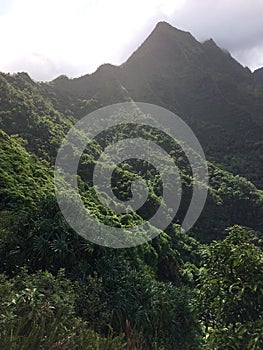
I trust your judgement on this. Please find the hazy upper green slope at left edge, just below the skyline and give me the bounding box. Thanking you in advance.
[0,73,75,160]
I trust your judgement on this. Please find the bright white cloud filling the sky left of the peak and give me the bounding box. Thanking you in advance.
[0,0,165,79]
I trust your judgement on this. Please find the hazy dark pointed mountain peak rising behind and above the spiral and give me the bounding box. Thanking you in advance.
[42,22,263,188]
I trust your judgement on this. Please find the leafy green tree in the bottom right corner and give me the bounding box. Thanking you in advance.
[198,226,263,350]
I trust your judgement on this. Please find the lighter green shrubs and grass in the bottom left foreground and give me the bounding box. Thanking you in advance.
[0,269,126,350]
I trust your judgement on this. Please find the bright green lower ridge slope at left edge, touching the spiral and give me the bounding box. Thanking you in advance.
[0,130,53,212]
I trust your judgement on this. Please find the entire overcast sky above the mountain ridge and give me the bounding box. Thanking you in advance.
[0,0,263,80]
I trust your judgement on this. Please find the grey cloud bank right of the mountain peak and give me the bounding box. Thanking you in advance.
[170,0,263,69]
